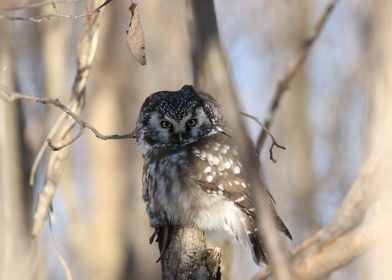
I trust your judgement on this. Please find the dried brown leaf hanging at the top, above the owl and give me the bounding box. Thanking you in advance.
[128,3,147,65]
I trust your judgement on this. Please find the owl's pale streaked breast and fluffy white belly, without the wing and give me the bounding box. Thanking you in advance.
[143,143,250,245]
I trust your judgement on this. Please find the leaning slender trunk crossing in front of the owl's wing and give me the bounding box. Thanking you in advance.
[190,0,291,280]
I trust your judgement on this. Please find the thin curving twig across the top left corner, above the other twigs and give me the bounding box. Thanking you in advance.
[0,0,113,23]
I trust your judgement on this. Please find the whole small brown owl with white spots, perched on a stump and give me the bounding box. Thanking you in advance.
[134,86,291,264]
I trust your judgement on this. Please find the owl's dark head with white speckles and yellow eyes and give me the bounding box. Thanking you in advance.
[134,85,224,154]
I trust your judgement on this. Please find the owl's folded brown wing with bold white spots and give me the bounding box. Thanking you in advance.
[190,133,292,239]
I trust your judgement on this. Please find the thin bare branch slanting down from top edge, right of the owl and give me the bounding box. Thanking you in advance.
[256,0,339,153]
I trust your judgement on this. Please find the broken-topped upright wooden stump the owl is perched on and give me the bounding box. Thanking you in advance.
[158,226,221,280]
